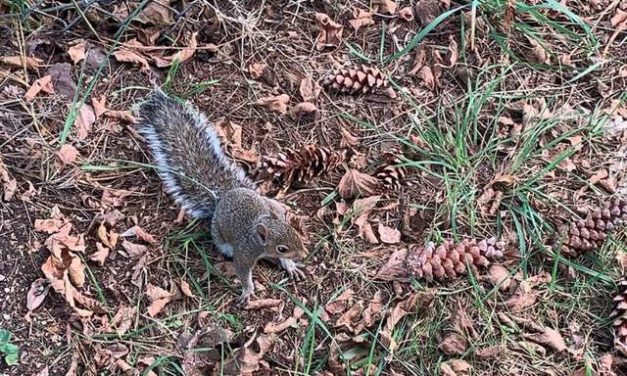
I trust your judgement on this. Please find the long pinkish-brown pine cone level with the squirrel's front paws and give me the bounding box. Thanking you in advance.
[405,238,505,281]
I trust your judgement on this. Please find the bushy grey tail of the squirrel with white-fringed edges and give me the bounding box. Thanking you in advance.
[138,88,254,218]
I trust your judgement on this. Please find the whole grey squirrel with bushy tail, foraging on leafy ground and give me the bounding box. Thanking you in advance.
[137,87,307,305]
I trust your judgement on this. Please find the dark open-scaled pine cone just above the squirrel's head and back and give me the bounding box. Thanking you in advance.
[252,145,345,189]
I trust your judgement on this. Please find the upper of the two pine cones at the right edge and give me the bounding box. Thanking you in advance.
[560,200,627,257]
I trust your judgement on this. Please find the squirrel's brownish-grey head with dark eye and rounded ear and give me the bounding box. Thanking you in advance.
[254,214,307,259]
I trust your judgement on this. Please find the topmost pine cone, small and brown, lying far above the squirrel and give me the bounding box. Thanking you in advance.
[323,65,388,94]
